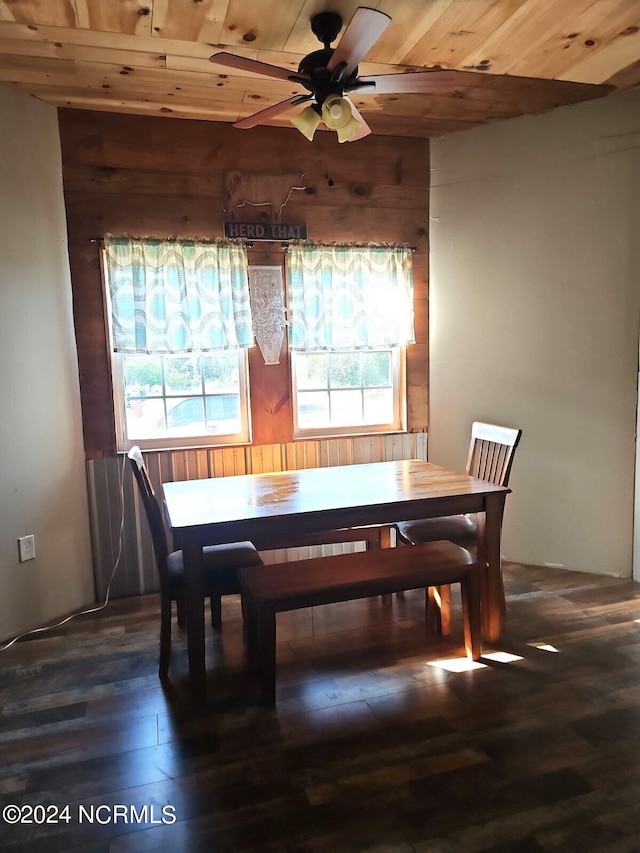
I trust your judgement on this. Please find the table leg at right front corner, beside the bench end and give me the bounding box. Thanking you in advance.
[478,492,506,642]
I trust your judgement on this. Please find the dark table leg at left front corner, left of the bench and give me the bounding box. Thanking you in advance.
[182,536,206,705]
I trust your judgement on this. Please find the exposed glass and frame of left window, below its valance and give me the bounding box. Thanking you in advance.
[114,350,250,448]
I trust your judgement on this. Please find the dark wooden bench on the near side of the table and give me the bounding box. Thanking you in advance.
[239,542,481,705]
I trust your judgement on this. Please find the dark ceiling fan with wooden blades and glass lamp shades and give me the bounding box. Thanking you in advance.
[209,6,610,142]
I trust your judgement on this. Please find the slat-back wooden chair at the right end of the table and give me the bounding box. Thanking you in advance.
[395,421,522,635]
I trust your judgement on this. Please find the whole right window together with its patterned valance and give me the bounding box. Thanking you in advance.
[287,244,413,438]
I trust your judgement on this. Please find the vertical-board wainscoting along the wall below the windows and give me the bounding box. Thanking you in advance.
[87,433,427,600]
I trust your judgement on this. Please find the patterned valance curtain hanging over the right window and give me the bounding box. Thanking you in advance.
[287,243,414,352]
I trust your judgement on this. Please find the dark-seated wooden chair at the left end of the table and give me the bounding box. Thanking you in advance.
[128,447,262,679]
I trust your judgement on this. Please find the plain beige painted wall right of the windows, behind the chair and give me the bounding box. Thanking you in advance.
[429,92,640,577]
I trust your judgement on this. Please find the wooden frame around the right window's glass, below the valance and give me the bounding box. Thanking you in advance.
[289,345,407,441]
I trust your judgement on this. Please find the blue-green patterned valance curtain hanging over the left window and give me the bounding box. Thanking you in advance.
[104,236,253,353]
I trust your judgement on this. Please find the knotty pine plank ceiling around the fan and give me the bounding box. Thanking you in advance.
[0,0,640,137]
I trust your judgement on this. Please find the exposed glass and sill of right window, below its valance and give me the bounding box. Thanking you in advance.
[291,347,405,438]
